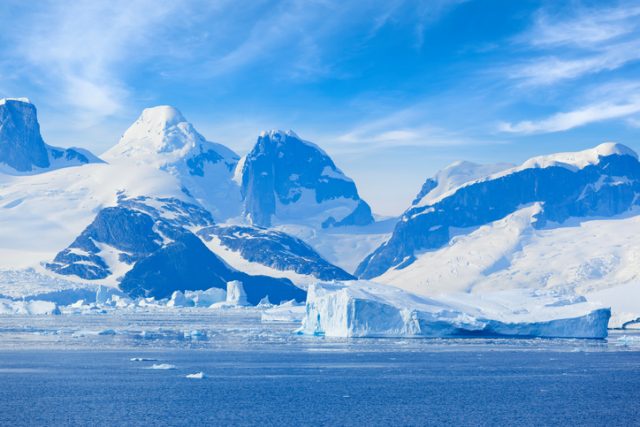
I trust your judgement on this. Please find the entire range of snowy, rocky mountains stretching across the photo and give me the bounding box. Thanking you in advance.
[0,98,640,328]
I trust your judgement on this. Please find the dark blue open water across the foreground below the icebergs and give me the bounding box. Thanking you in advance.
[0,346,640,426]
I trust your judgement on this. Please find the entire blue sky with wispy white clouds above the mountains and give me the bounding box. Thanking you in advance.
[0,0,640,215]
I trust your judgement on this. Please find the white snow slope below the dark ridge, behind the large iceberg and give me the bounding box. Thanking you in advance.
[375,204,640,327]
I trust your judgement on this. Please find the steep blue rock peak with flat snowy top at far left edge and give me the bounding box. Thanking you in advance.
[0,98,102,175]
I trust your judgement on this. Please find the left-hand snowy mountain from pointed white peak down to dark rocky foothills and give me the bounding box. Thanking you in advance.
[0,104,351,302]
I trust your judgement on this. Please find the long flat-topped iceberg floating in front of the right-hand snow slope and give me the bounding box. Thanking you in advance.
[299,281,611,338]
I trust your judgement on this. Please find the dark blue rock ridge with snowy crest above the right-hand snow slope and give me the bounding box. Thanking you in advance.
[356,144,640,278]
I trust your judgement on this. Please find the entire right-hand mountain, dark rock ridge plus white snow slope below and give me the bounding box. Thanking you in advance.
[358,143,640,328]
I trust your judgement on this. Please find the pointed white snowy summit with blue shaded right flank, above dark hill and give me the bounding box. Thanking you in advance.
[102,105,241,221]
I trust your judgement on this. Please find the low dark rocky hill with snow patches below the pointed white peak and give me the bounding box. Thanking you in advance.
[47,198,305,304]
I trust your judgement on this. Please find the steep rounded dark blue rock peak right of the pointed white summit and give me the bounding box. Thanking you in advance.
[238,130,373,228]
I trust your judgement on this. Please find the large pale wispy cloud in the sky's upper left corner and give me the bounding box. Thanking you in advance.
[3,0,180,124]
